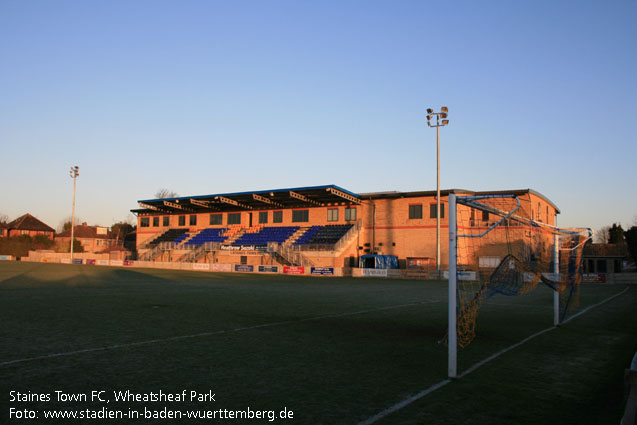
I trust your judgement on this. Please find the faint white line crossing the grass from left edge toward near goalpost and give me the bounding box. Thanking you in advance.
[0,300,440,367]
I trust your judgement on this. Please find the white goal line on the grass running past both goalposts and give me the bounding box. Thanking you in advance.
[358,287,630,425]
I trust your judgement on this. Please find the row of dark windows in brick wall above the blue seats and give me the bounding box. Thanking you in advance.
[139,208,356,227]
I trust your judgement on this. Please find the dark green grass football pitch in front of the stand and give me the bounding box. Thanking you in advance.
[0,262,637,424]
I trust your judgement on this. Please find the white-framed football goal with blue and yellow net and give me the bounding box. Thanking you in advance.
[448,193,592,377]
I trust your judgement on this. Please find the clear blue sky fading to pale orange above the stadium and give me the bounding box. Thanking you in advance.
[0,0,637,229]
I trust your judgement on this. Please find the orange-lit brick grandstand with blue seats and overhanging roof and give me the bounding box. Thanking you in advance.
[131,185,559,269]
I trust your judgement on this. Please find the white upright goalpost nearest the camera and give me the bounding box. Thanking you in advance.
[447,193,458,378]
